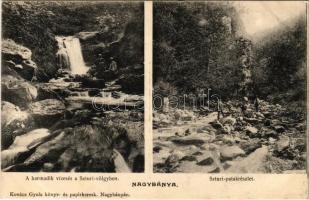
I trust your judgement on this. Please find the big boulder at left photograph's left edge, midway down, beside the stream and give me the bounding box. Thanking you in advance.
[1,75,38,107]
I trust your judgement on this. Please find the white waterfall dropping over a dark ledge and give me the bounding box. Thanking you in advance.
[56,36,89,74]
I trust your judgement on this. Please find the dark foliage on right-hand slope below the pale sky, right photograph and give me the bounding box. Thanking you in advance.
[253,16,307,102]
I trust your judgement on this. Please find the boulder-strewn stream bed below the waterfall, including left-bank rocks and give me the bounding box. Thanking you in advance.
[1,40,144,172]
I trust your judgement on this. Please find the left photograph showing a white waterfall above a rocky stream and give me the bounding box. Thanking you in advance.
[1,1,144,173]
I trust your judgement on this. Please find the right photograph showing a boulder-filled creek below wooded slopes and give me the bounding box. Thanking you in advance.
[153,1,307,174]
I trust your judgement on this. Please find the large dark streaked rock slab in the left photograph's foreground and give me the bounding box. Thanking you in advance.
[17,125,131,172]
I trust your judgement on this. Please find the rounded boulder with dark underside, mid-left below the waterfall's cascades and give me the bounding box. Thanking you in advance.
[29,99,66,127]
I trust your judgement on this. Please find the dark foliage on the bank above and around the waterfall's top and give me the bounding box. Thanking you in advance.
[2,1,143,77]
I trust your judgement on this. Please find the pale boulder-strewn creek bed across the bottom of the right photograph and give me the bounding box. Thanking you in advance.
[153,101,306,173]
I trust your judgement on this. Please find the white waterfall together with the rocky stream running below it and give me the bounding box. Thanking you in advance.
[1,36,144,172]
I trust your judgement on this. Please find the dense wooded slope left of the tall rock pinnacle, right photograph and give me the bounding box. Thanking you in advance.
[154,2,243,95]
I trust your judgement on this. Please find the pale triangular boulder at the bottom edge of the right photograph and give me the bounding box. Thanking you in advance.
[225,146,268,173]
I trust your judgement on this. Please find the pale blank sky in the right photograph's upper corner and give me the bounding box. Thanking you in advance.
[234,1,306,36]
